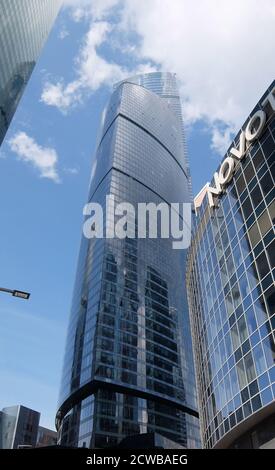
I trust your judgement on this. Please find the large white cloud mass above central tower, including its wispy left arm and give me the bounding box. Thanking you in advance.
[42,0,275,156]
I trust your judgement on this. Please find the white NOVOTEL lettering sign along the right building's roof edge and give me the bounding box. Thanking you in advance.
[206,86,275,207]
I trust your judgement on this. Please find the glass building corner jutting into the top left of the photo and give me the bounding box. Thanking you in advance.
[0,0,62,145]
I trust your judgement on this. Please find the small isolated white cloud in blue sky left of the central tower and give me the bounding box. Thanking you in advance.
[8,132,60,183]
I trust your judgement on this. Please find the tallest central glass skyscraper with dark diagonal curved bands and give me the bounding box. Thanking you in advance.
[56,73,199,448]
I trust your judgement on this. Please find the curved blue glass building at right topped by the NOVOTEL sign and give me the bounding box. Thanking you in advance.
[187,82,275,448]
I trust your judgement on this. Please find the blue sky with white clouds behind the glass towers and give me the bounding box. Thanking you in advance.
[0,0,275,427]
